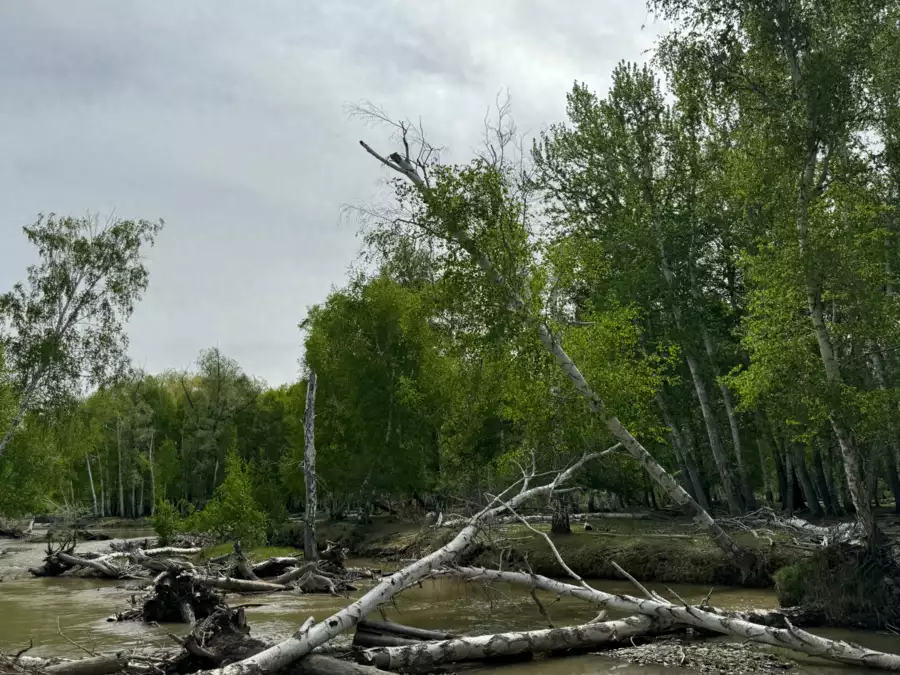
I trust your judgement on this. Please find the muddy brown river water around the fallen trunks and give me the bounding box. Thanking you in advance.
[0,530,900,675]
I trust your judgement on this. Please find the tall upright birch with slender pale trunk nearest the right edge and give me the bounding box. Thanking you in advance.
[652,0,897,542]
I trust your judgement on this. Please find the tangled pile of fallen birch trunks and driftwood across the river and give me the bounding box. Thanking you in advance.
[7,464,900,675]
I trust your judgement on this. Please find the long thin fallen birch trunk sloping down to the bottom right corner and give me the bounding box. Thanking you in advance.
[450,567,900,671]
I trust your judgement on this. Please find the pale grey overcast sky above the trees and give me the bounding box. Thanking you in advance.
[0,0,660,385]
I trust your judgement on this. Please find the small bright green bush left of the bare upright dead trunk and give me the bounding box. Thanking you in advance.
[189,452,268,547]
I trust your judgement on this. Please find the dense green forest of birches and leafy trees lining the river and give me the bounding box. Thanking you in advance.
[0,0,900,548]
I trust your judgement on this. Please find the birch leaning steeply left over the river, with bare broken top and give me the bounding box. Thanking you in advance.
[360,113,759,576]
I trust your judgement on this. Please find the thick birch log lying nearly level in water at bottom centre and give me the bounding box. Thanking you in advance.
[359,615,672,672]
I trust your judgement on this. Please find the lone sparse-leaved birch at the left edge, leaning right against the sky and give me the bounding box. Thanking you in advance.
[0,214,163,455]
